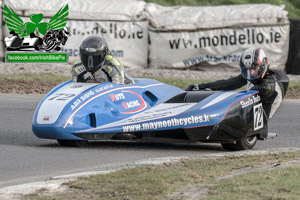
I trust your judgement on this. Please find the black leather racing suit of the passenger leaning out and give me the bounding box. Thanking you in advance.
[199,70,282,118]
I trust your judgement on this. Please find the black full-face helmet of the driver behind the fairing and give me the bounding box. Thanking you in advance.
[80,36,109,73]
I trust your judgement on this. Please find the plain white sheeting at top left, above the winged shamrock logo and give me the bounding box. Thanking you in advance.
[4,0,146,21]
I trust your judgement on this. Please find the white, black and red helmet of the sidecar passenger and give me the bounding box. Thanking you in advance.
[240,47,268,83]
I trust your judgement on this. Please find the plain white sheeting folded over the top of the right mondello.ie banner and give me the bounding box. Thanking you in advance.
[145,3,289,31]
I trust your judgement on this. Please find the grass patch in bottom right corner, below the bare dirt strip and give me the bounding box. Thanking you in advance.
[207,166,300,200]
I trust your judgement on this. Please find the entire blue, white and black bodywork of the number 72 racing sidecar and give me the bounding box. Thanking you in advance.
[32,79,267,141]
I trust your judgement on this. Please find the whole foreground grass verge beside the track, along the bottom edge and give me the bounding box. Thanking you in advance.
[24,151,300,200]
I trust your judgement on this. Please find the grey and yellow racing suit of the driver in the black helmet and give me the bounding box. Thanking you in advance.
[72,55,134,84]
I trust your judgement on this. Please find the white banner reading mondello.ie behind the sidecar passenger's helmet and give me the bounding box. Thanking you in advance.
[149,24,289,70]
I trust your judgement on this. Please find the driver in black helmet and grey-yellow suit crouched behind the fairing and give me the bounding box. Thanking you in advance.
[72,36,134,84]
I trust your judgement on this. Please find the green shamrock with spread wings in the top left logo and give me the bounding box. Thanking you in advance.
[3,4,69,37]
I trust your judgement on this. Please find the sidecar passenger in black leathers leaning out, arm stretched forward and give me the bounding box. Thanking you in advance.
[186,48,284,118]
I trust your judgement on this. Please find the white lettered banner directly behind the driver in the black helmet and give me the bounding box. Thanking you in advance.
[62,20,148,68]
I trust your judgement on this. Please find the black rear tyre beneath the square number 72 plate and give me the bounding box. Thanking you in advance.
[221,135,257,151]
